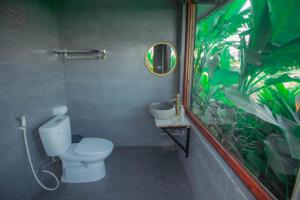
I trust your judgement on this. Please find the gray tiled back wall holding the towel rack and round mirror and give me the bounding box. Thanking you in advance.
[58,0,178,146]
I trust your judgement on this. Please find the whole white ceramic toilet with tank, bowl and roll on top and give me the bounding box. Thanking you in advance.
[39,106,113,183]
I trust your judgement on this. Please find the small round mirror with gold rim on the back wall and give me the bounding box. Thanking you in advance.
[145,42,177,76]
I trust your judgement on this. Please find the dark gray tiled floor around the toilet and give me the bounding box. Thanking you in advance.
[34,147,192,200]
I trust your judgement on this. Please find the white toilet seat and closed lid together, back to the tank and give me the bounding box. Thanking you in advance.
[60,138,113,162]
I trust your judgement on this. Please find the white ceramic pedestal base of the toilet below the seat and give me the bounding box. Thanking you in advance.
[61,160,106,183]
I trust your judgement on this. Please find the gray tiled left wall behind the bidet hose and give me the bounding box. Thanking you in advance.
[0,0,66,200]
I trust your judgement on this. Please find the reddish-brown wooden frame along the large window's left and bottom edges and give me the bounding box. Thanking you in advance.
[182,1,274,200]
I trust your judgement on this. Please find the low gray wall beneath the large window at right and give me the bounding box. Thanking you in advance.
[179,126,255,200]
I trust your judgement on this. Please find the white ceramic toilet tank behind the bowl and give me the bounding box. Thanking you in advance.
[39,115,72,156]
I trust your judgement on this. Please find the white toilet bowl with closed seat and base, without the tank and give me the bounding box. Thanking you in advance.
[60,138,113,183]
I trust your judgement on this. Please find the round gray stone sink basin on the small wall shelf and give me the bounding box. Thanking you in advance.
[149,102,176,119]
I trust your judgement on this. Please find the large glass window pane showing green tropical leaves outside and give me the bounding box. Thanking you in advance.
[190,0,300,199]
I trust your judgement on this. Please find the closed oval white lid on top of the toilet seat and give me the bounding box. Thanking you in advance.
[74,138,113,156]
